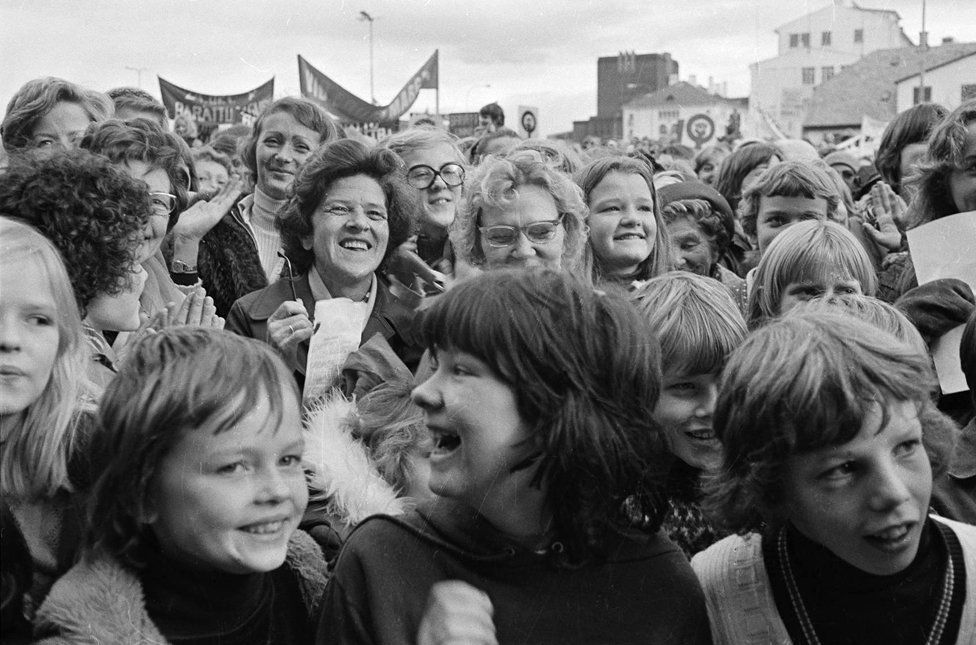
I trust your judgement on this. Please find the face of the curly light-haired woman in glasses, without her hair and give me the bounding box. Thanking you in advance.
[478,185,566,270]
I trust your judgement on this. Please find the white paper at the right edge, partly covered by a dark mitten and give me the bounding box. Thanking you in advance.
[908,211,976,394]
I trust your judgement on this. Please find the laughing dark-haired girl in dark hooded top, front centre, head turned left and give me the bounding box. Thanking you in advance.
[317,269,708,644]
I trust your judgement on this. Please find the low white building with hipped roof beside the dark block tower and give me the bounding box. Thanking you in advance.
[623,81,747,148]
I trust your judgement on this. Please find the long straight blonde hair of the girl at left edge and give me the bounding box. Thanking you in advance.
[0,217,97,500]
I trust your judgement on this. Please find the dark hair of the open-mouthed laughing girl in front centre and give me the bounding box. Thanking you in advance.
[420,269,670,562]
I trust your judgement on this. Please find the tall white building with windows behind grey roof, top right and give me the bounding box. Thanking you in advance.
[749,0,913,137]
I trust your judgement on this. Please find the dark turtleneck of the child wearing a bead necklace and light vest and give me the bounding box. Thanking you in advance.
[763,520,966,645]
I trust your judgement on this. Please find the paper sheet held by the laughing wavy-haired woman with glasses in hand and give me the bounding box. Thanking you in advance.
[302,298,369,403]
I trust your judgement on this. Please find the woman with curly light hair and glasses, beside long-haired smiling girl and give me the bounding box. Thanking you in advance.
[451,150,587,277]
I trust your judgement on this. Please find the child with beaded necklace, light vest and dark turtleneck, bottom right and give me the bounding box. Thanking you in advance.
[692,313,976,644]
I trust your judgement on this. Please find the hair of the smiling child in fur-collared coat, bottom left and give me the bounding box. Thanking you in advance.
[86,327,299,568]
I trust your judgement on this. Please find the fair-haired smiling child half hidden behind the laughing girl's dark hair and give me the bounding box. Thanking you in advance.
[633,271,746,557]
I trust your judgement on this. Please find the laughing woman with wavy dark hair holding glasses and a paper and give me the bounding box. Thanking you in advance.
[227,139,428,374]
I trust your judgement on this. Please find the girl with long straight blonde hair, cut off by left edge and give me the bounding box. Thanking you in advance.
[0,217,96,642]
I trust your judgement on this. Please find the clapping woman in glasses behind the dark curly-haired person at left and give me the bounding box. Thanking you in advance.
[81,119,225,332]
